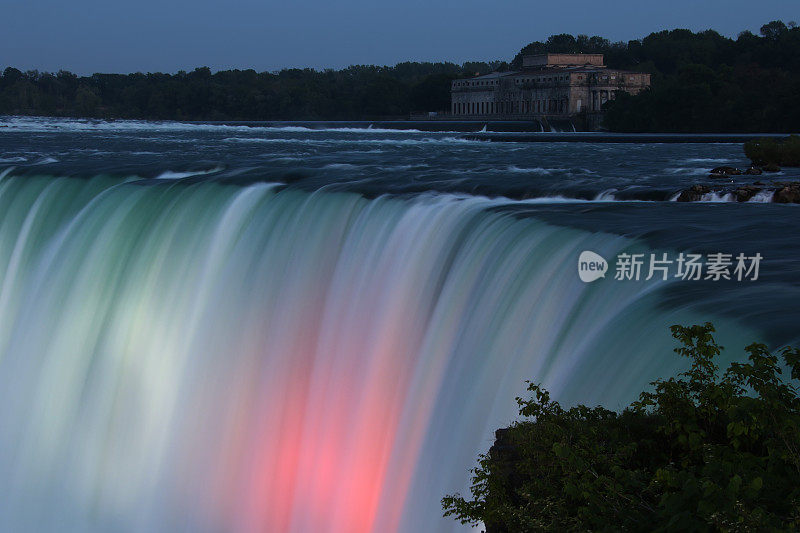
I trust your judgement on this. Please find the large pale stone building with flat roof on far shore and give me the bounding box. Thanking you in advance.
[450,54,650,120]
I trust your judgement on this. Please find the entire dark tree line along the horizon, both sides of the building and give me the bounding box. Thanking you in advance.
[0,21,800,132]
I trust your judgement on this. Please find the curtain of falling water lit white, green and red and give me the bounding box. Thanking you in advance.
[0,175,754,532]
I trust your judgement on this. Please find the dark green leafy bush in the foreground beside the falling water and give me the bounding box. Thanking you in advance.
[442,323,800,532]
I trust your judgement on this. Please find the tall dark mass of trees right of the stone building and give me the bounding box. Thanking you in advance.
[605,21,800,133]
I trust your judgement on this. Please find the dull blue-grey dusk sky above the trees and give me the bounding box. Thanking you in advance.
[0,0,800,74]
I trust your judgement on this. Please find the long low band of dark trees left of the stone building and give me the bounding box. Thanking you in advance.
[0,62,501,120]
